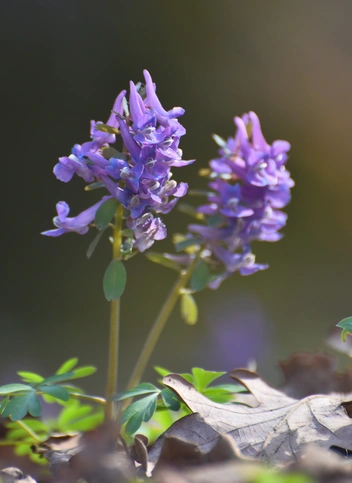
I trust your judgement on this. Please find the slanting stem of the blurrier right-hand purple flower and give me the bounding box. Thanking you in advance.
[127,249,202,389]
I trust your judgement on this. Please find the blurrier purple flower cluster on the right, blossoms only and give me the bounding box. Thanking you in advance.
[189,112,294,288]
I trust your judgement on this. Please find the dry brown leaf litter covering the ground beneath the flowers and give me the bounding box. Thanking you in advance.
[7,353,352,483]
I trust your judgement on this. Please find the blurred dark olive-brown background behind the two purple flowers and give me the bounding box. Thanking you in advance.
[0,0,352,392]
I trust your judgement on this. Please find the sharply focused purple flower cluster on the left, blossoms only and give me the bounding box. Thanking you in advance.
[43,70,194,252]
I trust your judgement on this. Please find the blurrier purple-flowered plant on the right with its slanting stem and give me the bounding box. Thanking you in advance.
[128,112,294,389]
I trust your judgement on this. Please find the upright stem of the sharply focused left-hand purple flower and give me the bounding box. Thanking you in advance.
[105,204,123,419]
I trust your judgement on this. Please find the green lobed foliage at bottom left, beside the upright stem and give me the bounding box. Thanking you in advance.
[0,358,105,462]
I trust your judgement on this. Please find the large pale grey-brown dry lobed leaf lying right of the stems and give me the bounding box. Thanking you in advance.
[163,369,352,465]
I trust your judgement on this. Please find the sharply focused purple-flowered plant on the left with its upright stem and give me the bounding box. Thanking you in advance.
[43,70,194,418]
